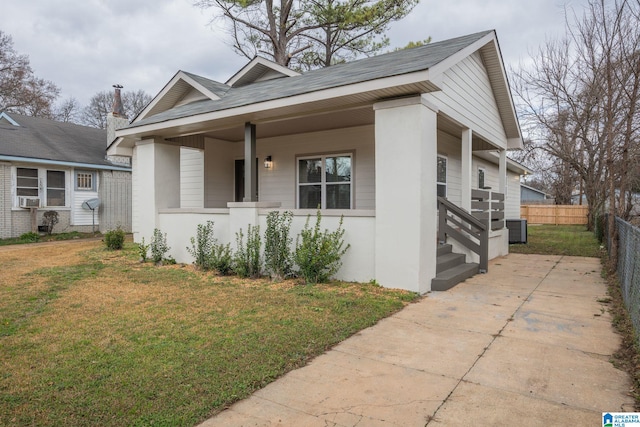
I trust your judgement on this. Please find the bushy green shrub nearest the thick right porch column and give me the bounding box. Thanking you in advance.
[295,210,351,283]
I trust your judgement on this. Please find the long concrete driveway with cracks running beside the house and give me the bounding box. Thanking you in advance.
[201,254,634,427]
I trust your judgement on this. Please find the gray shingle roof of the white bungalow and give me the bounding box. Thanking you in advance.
[128,31,492,128]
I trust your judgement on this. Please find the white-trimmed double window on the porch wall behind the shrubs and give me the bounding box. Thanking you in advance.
[298,153,353,209]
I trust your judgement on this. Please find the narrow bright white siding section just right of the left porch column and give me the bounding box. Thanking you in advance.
[180,147,204,208]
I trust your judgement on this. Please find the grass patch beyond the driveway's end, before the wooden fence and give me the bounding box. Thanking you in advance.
[509,225,601,258]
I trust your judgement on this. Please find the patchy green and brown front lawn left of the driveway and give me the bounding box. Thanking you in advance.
[0,242,417,426]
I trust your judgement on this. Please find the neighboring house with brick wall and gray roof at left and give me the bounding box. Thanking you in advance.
[0,102,131,238]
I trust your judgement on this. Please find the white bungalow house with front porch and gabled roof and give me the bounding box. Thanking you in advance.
[108,31,524,293]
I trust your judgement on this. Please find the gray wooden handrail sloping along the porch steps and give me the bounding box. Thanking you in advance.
[438,197,489,273]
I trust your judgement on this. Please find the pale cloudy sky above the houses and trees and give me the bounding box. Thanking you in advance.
[0,0,587,105]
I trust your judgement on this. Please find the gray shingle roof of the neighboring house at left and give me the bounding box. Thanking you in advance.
[0,113,129,166]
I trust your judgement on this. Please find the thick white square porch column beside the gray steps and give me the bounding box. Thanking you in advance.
[374,96,437,293]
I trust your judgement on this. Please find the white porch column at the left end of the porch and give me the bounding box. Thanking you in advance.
[132,138,180,242]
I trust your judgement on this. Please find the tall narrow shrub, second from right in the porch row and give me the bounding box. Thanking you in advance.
[264,211,293,280]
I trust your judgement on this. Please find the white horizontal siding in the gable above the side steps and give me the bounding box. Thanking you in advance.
[429,52,507,148]
